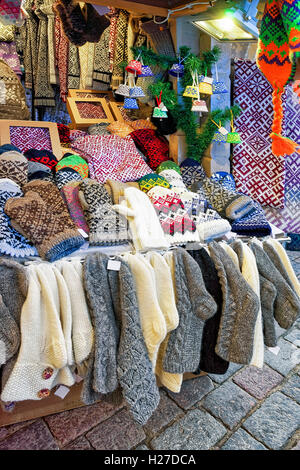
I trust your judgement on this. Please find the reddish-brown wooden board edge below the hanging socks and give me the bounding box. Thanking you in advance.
[0,372,206,428]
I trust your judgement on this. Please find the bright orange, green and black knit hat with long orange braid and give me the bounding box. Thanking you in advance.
[257,0,300,156]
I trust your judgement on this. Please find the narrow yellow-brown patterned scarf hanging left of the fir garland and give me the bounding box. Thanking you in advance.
[111,10,129,89]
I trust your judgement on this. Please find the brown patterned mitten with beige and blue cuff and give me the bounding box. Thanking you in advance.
[5,191,84,261]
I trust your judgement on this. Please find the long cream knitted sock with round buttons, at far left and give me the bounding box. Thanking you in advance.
[1,264,67,401]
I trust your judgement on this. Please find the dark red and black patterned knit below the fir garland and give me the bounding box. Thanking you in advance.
[130,129,169,171]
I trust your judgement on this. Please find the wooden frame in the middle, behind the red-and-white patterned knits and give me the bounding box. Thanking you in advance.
[67,97,115,129]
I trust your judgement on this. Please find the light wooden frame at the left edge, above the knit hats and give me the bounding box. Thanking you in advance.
[0,119,63,160]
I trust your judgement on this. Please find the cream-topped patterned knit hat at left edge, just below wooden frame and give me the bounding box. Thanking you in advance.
[0,150,28,186]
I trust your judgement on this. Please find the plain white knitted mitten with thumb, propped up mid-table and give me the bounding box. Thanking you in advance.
[114,187,170,251]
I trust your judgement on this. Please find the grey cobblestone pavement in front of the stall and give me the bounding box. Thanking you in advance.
[0,252,300,450]
